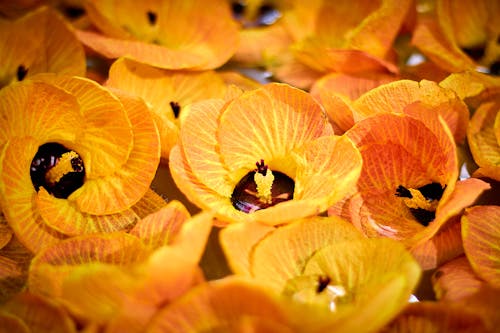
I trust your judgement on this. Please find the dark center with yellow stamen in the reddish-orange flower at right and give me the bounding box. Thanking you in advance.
[395,183,446,227]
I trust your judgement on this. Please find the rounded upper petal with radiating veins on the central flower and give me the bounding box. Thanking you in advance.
[218,84,333,179]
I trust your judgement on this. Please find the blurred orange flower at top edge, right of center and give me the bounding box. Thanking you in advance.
[271,0,412,88]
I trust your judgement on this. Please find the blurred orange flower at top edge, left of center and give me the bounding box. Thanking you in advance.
[77,0,238,70]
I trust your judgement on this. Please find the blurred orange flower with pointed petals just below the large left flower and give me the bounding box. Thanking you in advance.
[28,201,212,332]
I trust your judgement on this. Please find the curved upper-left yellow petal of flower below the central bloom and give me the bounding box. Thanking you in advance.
[250,216,362,292]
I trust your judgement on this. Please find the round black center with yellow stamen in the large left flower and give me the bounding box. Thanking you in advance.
[30,142,85,199]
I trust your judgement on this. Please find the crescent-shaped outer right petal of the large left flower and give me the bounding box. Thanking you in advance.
[75,92,160,214]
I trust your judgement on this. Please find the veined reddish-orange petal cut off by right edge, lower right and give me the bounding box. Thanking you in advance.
[462,206,500,288]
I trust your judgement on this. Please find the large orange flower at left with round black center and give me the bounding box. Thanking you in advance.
[0,75,164,252]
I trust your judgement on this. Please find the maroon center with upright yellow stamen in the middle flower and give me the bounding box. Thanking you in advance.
[231,160,295,213]
